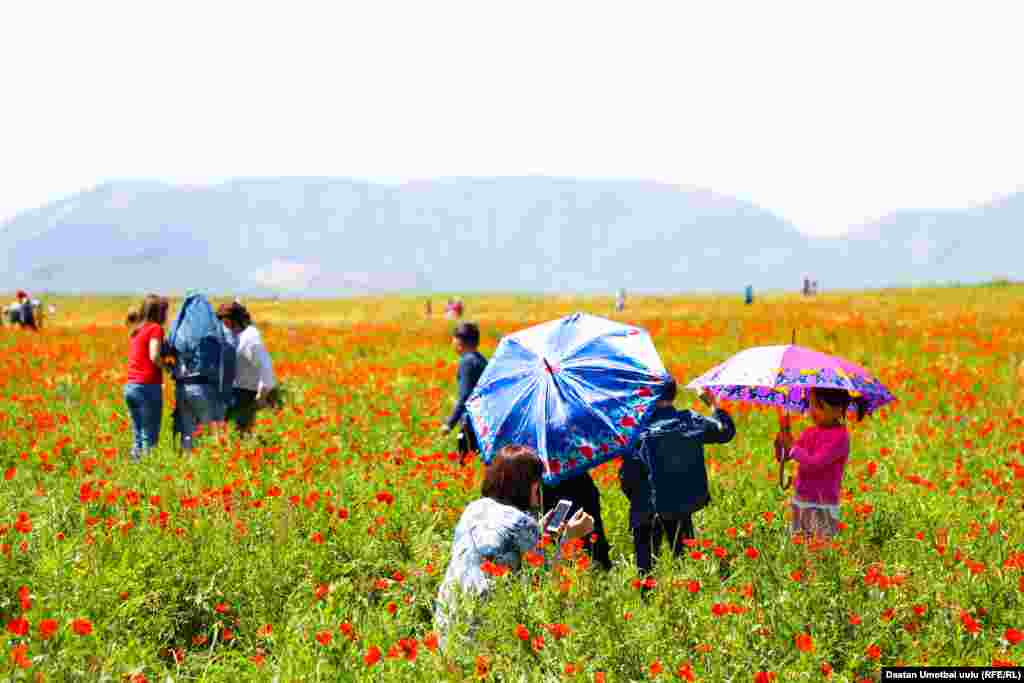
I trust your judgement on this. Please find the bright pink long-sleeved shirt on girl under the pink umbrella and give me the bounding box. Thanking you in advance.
[790,425,850,505]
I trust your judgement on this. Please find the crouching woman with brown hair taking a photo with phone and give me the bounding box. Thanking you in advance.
[434,445,594,646]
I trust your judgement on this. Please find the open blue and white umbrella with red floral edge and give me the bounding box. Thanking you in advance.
[466,313,668,483]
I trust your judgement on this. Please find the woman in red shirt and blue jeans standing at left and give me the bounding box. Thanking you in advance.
[125,294,168,462]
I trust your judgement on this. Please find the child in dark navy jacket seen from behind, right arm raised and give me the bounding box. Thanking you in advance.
[618,378,736,574]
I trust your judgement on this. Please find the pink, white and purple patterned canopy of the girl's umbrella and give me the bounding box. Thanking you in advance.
[686,345,895,413]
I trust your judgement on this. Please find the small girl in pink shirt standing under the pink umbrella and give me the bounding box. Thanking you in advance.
[775,388,864,538]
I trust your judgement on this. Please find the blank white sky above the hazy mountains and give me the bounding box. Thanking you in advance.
[0,0,1024,236]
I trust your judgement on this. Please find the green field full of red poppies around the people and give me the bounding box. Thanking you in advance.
[0,286,1024,683]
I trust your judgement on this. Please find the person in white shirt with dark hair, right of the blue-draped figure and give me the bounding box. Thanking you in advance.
[217,303,278,433]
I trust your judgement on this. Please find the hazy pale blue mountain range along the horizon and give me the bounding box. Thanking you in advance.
[0,177,1024,296]
